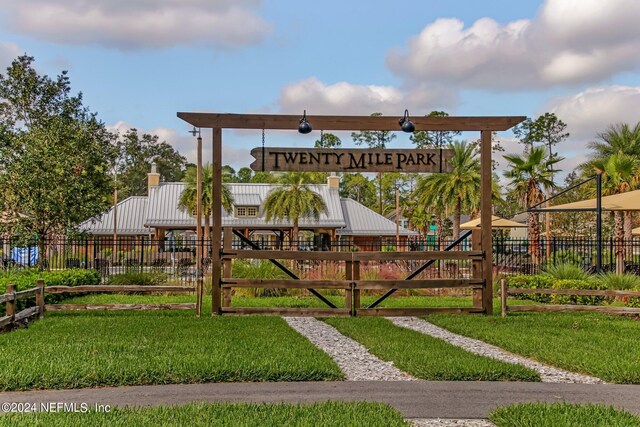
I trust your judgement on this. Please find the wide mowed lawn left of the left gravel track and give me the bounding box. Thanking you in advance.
[0,311,343,390]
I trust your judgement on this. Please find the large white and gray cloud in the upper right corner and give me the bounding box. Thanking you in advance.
[387,0,640,90]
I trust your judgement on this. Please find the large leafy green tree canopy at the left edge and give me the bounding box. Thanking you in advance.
[0,55,116,254]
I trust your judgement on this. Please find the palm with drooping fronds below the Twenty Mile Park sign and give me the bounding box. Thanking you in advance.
[264,172,327,250]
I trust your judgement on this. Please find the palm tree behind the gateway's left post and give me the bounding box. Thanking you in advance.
[178,163,233,240]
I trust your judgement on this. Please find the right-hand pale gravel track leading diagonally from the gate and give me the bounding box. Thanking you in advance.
[387,317,604,384]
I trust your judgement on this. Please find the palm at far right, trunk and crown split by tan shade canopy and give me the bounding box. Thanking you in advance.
[589,152,640,274]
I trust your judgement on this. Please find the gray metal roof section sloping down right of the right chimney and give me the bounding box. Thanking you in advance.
[336,199,418,236]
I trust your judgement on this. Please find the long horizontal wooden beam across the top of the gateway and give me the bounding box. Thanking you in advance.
[178,112,526,131]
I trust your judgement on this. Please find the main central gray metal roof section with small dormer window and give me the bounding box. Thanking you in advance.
[145,182,345,228]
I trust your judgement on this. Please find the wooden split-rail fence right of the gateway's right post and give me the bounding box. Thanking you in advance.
[500,279,640,317]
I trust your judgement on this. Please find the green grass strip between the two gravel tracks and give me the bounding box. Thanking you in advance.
[324,317,540,381]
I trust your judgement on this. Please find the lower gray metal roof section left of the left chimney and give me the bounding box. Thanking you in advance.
[78,196,152,236]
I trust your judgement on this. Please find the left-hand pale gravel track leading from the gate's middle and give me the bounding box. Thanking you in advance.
[283,317,414,381]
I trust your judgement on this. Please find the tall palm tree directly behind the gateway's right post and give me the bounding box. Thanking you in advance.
[422,142,481,239]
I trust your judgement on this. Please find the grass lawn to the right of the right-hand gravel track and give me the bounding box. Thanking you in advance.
[426,312,640,384]
